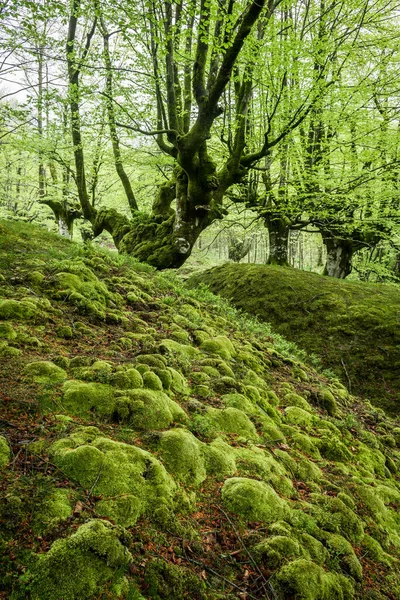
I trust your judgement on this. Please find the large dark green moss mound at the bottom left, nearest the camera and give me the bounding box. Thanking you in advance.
[31,520,132,600]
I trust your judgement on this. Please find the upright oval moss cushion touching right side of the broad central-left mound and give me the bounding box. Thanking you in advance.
[160,429,206,485]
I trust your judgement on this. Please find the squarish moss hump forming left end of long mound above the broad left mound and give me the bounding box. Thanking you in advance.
[62,379,115,417]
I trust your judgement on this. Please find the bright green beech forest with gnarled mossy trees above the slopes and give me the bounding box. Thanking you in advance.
[0,0,400,281]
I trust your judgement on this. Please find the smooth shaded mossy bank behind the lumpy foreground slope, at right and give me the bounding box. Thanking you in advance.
[190,264,400,414]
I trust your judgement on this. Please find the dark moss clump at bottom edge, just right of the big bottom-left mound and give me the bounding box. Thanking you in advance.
[144,558,207,600]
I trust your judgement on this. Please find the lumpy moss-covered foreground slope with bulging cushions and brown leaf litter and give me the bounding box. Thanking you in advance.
[0,224,400,600]
